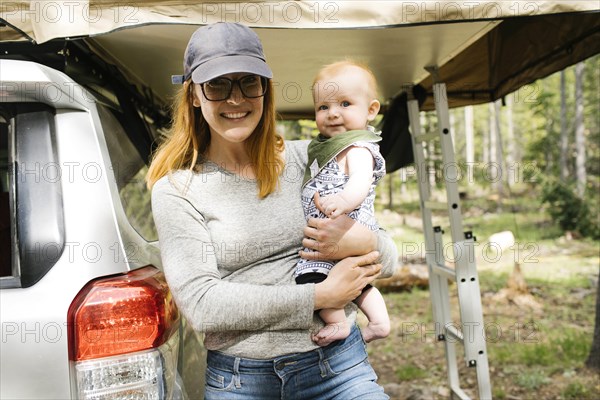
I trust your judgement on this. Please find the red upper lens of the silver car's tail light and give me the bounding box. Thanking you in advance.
[68,267,179,361]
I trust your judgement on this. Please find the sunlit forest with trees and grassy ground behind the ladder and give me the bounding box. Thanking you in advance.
[280,56,600,399]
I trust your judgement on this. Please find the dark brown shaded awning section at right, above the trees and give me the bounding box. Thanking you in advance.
[421,13,600,109]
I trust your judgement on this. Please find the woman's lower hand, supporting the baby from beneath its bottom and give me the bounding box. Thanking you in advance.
[315,251,381,310]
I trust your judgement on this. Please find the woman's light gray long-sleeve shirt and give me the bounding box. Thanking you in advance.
[152,141,397,359]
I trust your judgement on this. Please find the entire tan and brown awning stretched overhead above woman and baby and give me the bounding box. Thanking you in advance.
[0,0,600,117]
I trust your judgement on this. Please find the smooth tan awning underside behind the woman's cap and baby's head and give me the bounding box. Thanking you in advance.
[91,21,498,118]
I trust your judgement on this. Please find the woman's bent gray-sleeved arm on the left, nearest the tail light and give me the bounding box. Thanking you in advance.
[152,180,315,332]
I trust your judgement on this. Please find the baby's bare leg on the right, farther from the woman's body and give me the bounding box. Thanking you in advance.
[355,287,390,343]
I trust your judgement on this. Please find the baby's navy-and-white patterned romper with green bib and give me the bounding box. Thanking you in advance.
[295,131,385,283]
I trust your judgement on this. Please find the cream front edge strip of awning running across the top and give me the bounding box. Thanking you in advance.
[0,0,598,43]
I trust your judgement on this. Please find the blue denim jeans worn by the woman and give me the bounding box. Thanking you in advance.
[204,326,389,400]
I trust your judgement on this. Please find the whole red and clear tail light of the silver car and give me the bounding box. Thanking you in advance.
[68,267,179,400]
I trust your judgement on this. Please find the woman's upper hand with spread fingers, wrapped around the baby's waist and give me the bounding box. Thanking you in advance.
[300,193,377,260]
